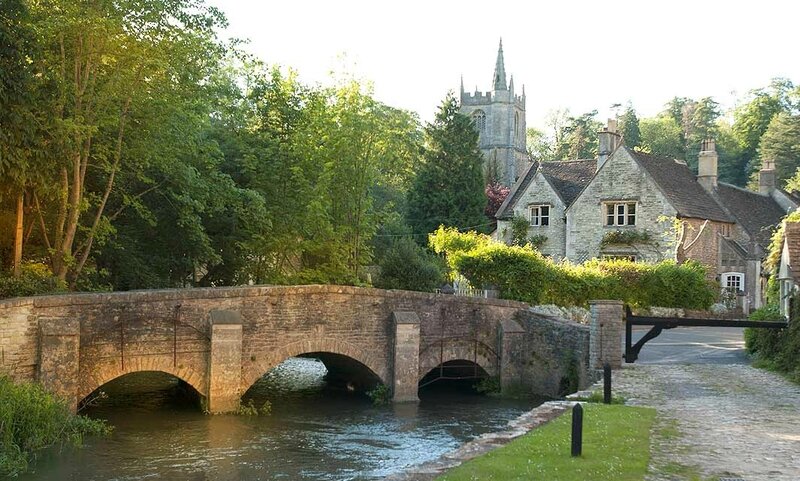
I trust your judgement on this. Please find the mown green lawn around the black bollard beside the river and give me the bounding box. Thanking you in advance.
[437,404,656,481]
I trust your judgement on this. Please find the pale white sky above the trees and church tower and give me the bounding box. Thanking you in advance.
[209,0,800,127]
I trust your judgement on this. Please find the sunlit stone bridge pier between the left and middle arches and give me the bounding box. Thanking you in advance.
[207,310,242,414]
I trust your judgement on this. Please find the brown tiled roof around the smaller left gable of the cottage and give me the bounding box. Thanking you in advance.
[497,159,597,219]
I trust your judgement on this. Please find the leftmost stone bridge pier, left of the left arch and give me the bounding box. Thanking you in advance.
[38,318,81,412]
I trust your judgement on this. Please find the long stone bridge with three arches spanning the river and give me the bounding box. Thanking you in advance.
[0,286,600,412]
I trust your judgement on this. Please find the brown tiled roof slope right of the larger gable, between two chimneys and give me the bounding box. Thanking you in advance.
[623,147,733,222]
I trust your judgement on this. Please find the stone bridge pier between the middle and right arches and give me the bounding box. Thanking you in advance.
[392,311,420,402]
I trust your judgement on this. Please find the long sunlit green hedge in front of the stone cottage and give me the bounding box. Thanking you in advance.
[430,228,718,309]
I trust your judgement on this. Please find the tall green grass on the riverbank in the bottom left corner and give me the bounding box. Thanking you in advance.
[0,376,110,478]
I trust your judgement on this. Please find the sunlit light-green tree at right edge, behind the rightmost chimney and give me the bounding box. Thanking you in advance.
[758,113,800,187]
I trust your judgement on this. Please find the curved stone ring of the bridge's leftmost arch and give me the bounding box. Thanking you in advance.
[77,357,208,402]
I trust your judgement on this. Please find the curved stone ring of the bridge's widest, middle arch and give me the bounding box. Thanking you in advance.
[240,338,390,394]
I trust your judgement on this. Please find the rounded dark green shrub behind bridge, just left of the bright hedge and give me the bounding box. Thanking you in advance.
[375,237,445,292]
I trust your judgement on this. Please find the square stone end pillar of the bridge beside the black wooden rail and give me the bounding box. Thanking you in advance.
[589,300,625,369]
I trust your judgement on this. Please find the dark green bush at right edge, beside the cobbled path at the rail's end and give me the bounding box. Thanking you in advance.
[744,299,800,383]
